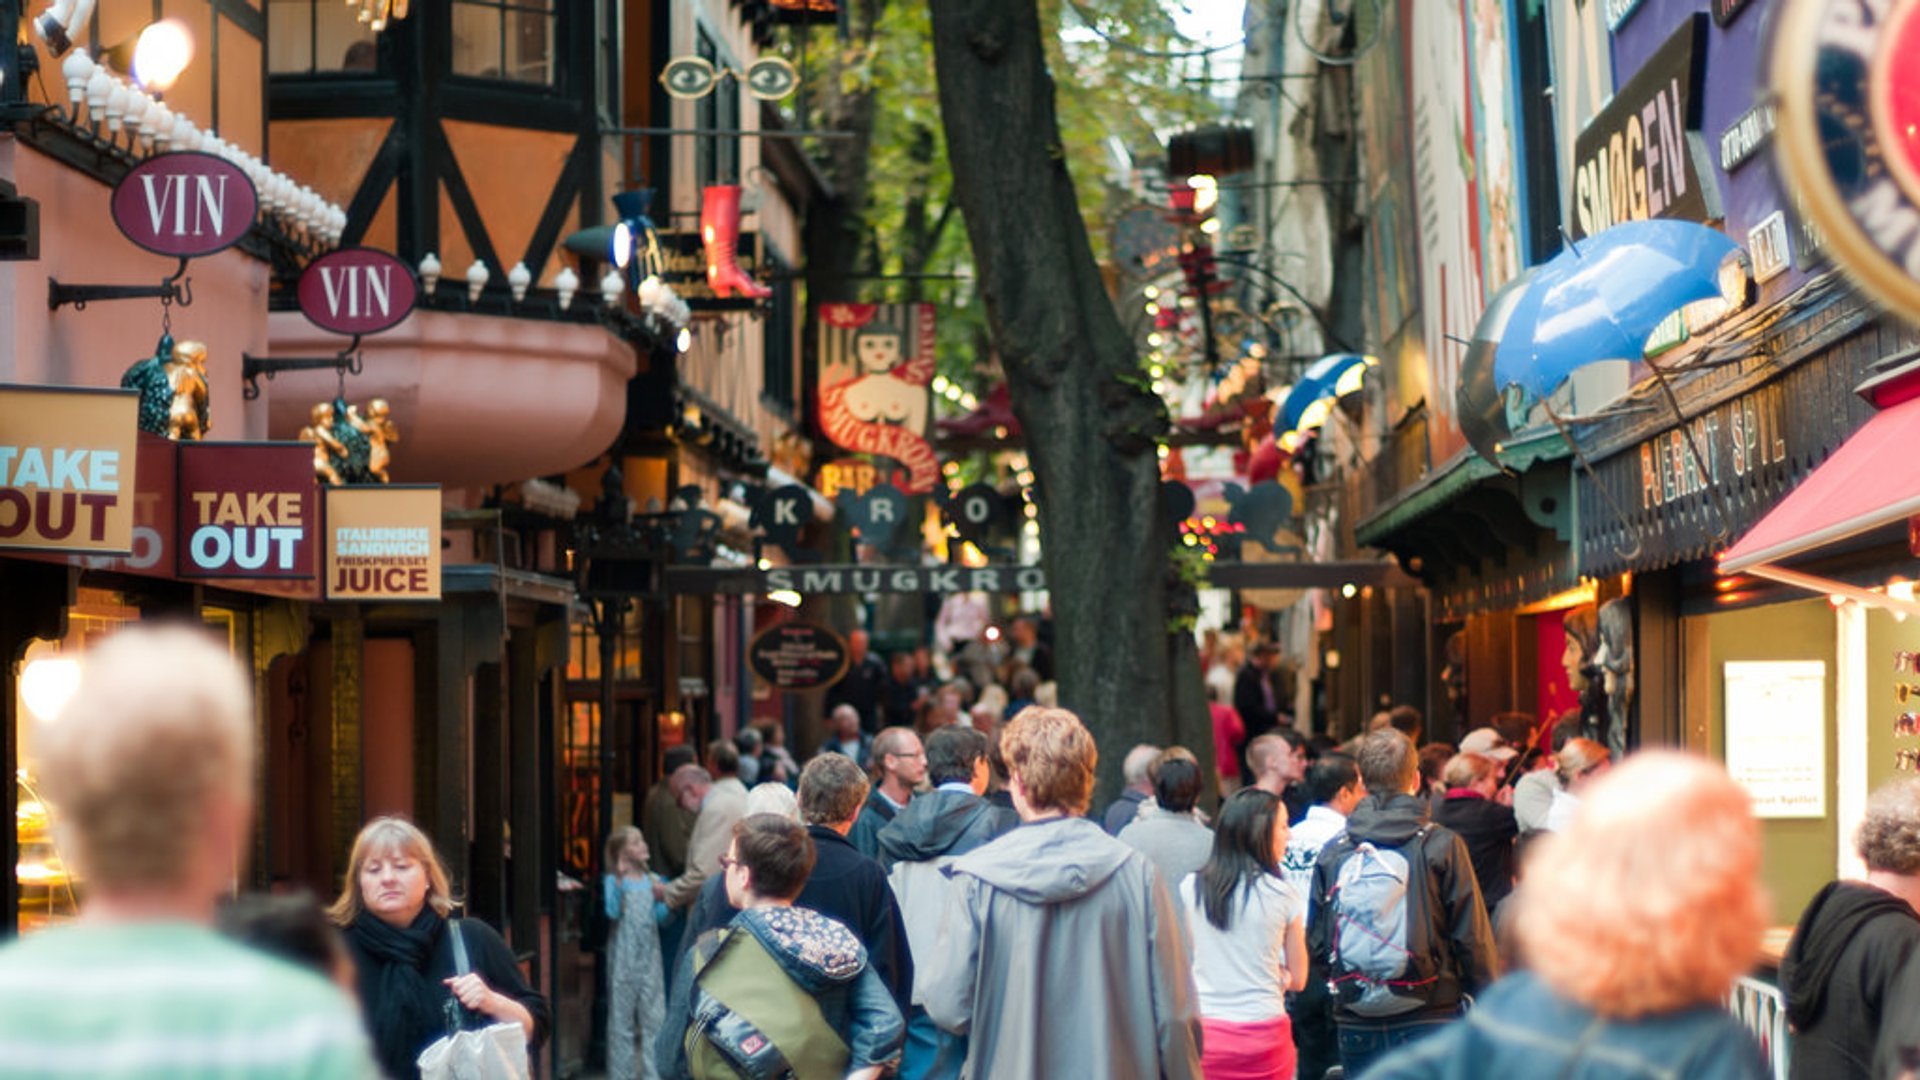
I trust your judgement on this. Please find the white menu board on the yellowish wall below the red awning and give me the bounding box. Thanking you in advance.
[1726,659,1826,817]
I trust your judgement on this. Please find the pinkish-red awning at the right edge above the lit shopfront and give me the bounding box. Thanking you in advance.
[1720,386,1920,575]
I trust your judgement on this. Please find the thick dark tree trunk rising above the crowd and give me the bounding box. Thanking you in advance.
[929,0,1213,796]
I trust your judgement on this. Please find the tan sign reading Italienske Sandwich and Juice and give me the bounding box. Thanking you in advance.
[324,484,440,600]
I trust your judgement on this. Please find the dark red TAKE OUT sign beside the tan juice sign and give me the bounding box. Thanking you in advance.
[177,442,319,580]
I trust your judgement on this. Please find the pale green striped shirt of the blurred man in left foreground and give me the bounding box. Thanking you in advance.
[0,922,378,1080]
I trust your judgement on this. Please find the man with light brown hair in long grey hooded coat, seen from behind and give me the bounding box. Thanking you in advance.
[916,705,1200,1080]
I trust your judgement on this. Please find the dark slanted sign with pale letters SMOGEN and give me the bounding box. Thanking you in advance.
[1572,15,1720,240]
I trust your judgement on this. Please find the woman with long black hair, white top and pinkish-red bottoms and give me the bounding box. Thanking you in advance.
[1181,788,1308,1080]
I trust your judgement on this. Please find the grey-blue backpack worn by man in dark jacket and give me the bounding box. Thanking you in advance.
[1329,824,1438,1017]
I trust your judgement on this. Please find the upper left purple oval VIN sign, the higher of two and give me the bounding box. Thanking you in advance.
[113,150,259,259]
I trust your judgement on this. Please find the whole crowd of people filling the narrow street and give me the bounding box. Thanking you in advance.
[18,628,1920,1080]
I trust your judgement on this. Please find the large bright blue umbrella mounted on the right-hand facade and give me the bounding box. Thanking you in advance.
[1494,221,1740,398]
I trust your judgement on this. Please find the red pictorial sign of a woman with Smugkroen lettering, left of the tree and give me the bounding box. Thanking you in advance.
[816,304,941,496]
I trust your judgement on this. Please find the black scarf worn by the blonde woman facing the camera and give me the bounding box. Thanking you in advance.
[348,905,447,1078]
